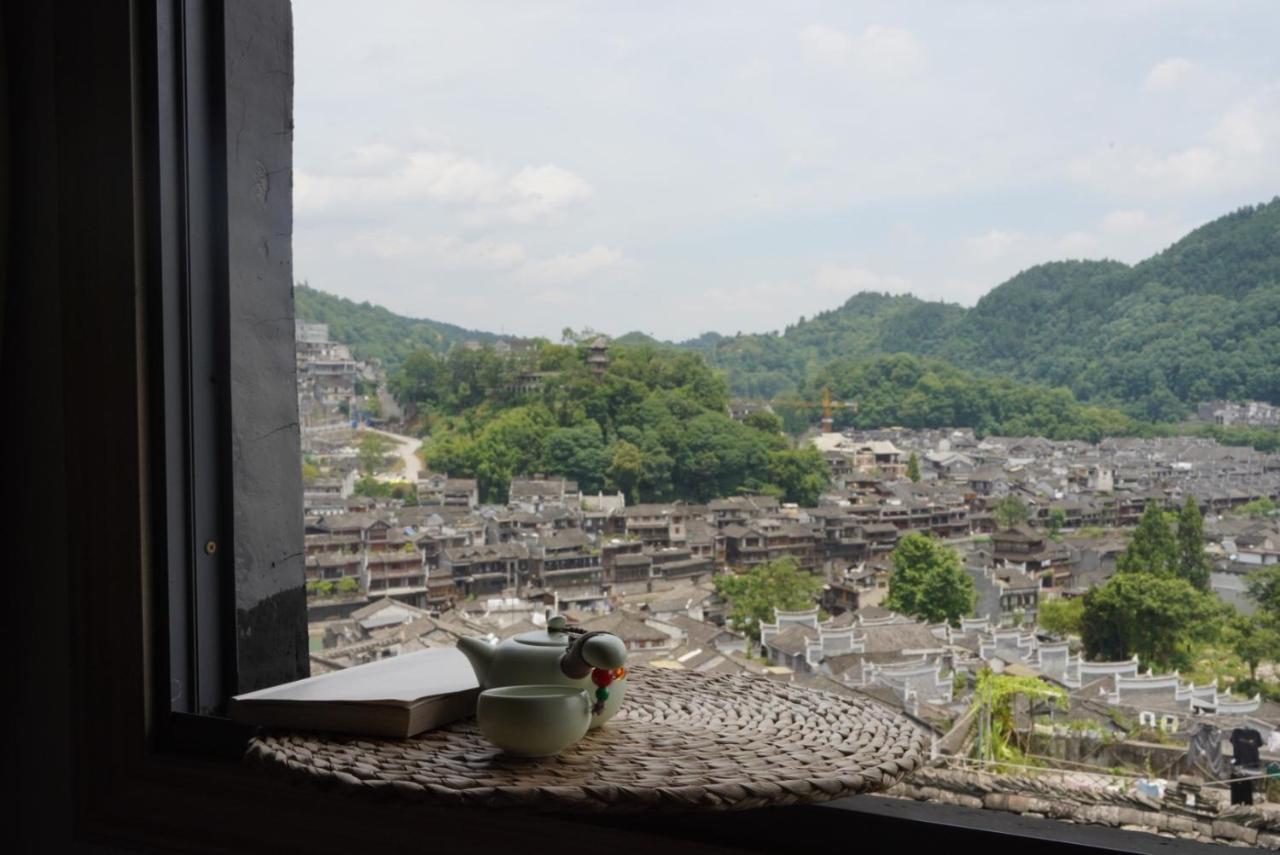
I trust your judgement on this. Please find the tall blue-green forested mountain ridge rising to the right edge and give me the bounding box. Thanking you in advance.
[684,200,1280,421]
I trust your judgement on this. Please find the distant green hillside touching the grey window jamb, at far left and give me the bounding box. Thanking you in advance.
[293,284,498,366]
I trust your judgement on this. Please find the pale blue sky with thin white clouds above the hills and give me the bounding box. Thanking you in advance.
[293,0,1280,340]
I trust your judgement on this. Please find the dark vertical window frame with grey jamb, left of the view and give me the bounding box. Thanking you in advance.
[143,0,307,732]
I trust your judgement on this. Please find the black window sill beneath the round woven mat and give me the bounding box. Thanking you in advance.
[147,715,1221,855]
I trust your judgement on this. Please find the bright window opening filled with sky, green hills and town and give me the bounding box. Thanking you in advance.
[267,3,1280,842]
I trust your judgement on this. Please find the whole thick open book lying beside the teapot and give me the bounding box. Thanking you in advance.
[229,648,480,736]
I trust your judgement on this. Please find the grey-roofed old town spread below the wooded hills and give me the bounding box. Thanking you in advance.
[298,317,1280,842]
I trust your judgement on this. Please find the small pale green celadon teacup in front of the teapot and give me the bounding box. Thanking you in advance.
[476,686,591,756]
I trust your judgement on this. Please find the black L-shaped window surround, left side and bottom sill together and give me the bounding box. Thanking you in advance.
[0,0,1233,852]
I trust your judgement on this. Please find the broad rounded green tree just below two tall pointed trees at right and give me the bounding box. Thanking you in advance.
[1080,572,1221,669]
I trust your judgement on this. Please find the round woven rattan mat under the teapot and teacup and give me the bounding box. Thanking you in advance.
[248,667,924,811]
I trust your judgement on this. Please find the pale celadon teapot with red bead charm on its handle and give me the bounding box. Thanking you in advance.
[458,614,627,727]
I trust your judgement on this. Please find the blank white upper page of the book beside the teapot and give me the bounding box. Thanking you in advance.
[234,648,479,703]
